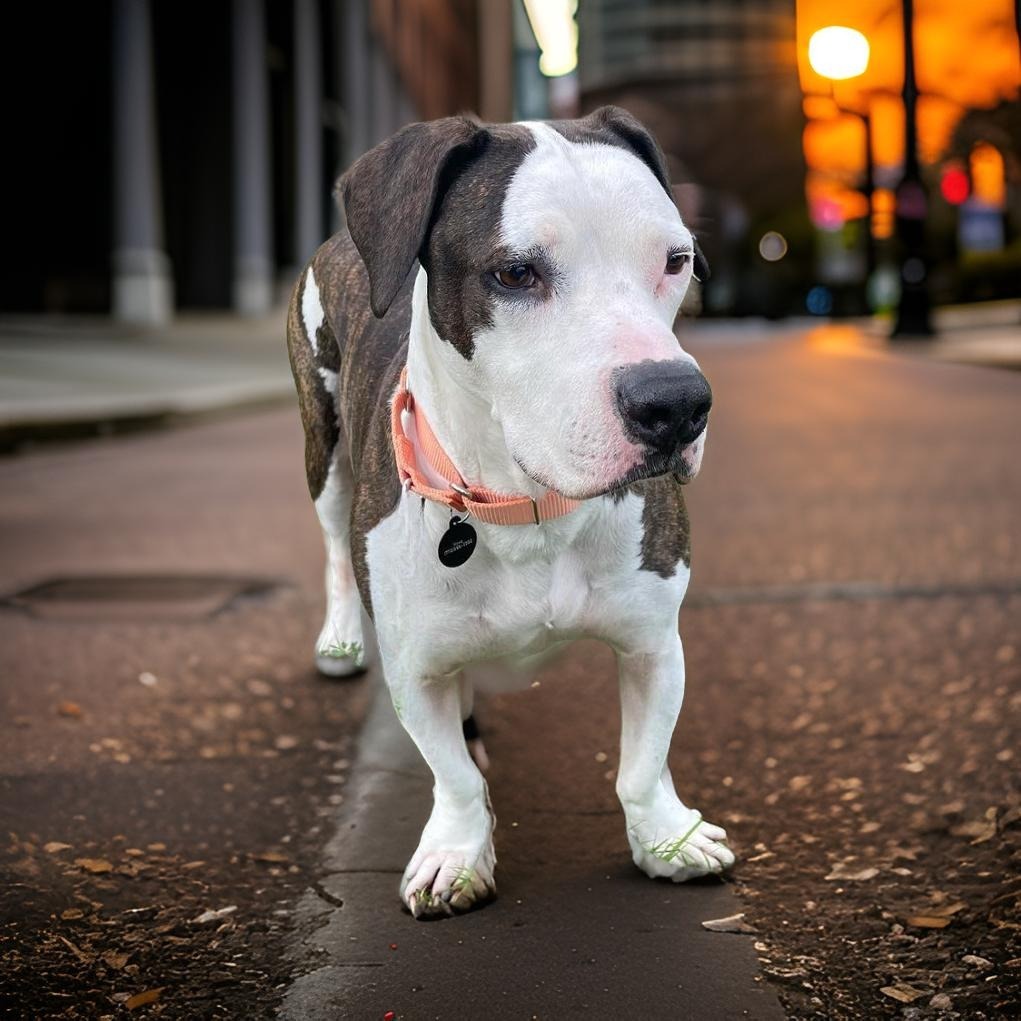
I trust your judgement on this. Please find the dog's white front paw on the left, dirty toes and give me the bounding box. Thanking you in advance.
[400,826,496,918]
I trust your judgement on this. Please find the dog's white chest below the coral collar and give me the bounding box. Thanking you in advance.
[369,496,687,672]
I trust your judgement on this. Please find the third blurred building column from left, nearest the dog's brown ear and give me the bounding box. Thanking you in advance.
[294,0,324,266]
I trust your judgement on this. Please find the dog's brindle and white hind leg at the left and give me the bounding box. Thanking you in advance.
[287,266,364,677]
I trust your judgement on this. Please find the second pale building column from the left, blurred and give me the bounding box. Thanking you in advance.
[233,0,273,315]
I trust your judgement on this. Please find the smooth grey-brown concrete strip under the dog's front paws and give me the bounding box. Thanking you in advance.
[280,669,784,1021]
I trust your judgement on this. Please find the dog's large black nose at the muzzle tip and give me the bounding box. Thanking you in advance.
[617,359,713,454]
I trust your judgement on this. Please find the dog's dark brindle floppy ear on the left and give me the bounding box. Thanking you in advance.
[336,117,488,319]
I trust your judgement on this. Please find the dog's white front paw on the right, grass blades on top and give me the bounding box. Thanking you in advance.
[628,809,734,883]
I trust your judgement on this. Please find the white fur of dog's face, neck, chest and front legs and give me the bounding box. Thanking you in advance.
[321,125,733,916]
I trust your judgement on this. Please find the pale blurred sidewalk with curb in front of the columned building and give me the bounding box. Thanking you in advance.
[0,308,294,449]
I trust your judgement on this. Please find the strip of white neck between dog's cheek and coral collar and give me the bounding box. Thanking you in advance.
[407,268,546,498]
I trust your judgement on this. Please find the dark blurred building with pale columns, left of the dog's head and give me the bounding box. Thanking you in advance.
[0,0,514,324]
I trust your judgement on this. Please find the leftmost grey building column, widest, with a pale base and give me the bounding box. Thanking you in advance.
[112,0,174,326]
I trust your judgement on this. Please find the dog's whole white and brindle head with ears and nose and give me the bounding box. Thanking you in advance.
[339,106,712,498]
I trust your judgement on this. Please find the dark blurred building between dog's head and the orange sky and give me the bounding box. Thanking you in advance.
[578,0,810,314]
